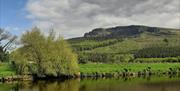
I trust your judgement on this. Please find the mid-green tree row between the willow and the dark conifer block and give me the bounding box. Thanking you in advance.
[78,53,134,63]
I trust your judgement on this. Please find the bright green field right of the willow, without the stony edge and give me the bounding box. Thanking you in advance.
[80,63,180,73]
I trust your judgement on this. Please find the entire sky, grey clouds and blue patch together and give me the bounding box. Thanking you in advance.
[0,0,180,38]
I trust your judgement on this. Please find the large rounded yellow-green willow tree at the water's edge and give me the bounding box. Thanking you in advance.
[12,28,79,77]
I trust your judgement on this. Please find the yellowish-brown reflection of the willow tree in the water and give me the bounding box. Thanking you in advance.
[14,80,79,91]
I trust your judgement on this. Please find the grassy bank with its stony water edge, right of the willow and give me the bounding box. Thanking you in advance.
[80,63,180,77]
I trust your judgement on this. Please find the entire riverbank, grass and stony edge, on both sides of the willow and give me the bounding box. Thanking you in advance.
[0,63,180,82]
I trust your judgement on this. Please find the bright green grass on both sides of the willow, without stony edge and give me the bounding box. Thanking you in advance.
[0,63,180,77]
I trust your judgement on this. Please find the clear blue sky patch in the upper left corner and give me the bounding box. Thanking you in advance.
[0,0,32,35]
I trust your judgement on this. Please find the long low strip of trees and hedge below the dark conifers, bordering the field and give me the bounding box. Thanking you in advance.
[78,53,180,64]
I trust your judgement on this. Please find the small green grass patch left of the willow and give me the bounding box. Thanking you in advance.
[0,63,16,77]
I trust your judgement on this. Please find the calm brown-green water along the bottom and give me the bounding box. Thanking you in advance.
[0,77,180,91]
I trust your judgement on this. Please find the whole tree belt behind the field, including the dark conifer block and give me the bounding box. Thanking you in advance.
[78,46,180,63]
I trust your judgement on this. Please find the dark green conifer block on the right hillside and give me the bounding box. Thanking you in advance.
[134,46,180,58]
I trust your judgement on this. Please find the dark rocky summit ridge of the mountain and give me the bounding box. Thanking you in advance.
[84,25,177,38]
